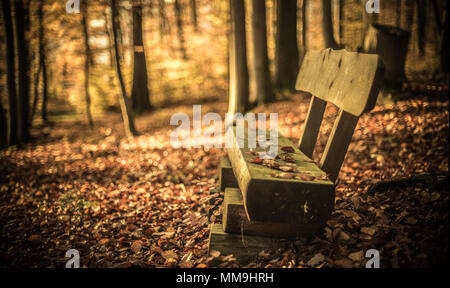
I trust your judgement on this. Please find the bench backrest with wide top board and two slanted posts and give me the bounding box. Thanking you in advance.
[295,49,384,181]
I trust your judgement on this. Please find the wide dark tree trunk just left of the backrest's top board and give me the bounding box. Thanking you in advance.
[274,0,299,89]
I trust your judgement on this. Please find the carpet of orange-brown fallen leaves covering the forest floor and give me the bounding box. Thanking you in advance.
[0,89,449,267]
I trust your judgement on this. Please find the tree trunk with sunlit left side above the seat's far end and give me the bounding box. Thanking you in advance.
[228,0,249,113]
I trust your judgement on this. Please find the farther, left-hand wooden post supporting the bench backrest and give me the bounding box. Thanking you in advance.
[299,96,327,158]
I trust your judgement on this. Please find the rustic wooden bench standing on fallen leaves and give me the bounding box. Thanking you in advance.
[210,49,384,260]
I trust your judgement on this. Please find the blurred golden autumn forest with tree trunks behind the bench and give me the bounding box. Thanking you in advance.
[0,0,448,146]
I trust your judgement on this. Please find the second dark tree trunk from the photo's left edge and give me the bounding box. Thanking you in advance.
[15,0,30,142]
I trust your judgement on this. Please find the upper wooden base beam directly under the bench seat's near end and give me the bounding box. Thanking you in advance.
[222,188,322,239]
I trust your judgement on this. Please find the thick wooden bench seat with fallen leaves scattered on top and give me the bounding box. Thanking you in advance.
[227,127,334,226]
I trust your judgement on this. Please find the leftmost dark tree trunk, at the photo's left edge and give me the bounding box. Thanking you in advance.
[2,0,19,145]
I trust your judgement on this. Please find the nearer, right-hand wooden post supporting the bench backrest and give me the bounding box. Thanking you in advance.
[320,109,359,181]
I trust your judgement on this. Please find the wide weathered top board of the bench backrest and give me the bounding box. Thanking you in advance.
[295,49,384,116]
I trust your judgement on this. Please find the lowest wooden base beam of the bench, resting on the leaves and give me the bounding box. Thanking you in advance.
[208,224,291,265]
